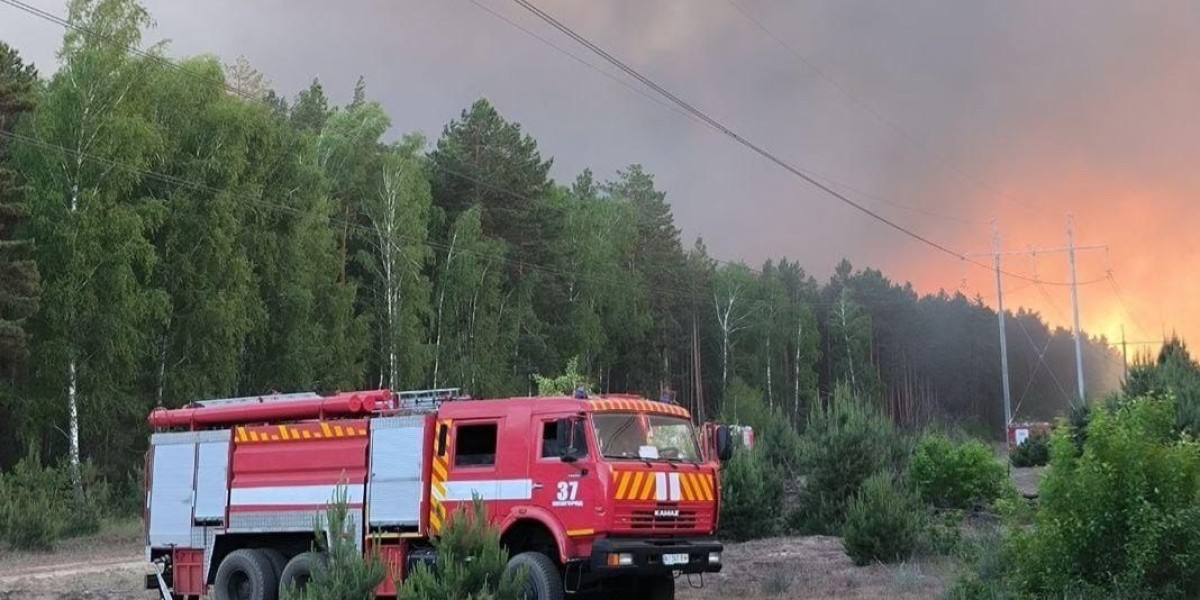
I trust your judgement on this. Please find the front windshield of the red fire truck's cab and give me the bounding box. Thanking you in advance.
[592,413,701,462]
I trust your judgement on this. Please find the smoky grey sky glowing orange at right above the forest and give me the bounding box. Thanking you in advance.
[0,0,1200,350]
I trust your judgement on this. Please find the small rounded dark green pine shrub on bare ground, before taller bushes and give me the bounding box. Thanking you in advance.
[842,473,924,566]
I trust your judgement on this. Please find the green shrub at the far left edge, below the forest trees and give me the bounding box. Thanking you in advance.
[0,450,67,552]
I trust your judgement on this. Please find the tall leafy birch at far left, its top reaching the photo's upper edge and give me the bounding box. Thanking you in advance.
[17,0,163,494]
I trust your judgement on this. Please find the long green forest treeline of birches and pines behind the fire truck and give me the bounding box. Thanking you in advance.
[0,0,1121,476]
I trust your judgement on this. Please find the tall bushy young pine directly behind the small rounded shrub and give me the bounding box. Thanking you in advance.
[791,386,910,534]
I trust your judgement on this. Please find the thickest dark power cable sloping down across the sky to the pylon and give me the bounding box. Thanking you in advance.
[512,0,1094,286]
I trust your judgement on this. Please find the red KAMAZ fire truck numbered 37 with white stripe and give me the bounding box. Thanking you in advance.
[145,390,732,600]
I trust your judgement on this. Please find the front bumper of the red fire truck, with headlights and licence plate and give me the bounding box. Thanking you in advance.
[590,538,725,576]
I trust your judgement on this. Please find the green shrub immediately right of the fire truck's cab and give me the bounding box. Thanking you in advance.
[720,448,784,541]
